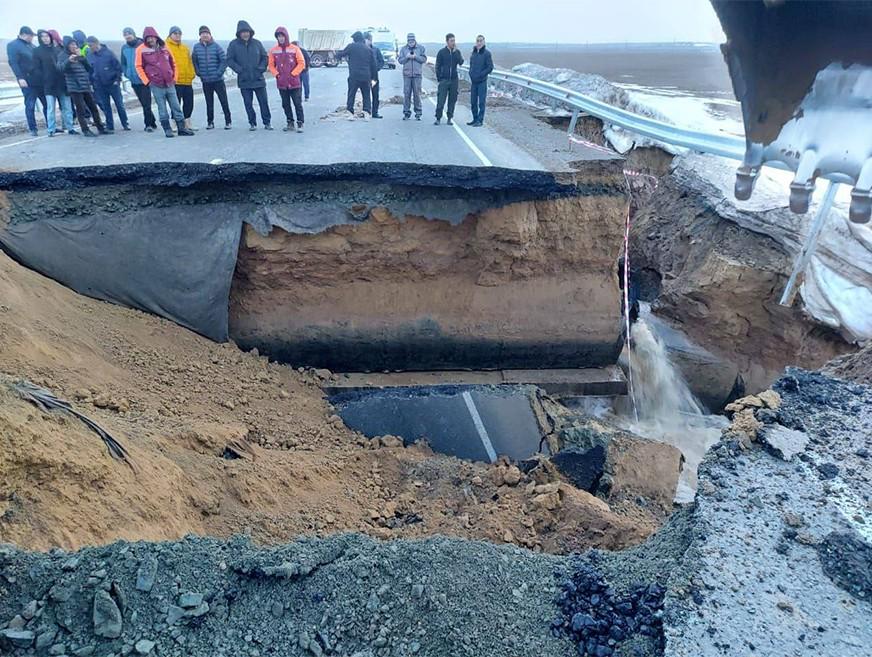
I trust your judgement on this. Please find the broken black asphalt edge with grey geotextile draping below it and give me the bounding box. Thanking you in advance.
[0,163,623,358]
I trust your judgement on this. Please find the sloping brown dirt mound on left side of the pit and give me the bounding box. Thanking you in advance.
[0,255,660,552]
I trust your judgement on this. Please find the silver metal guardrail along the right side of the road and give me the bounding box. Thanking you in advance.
[461,66,745,160]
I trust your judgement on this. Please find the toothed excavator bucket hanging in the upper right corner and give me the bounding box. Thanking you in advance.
[711,0,872,223]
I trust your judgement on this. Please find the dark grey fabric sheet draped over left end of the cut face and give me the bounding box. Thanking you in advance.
[0,207,242,342]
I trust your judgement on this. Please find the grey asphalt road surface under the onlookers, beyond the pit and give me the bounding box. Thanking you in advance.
[0,67,545,170]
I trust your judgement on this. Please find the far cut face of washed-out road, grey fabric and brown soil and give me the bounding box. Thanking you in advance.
[0,162,626,371]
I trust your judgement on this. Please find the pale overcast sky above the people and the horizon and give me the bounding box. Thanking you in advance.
[0,0,723,43]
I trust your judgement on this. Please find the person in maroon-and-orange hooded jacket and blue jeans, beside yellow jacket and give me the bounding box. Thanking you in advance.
[136,26,194,137]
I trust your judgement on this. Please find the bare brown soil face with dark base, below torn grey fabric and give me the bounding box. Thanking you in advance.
[230,194,625,371]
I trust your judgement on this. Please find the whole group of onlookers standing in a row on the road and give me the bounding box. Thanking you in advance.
[6,20,493,137]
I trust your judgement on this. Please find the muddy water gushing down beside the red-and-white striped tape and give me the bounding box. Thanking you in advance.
[619,320,727,503]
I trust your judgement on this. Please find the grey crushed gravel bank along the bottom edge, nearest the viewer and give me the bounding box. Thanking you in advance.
[0,534,574,657]
